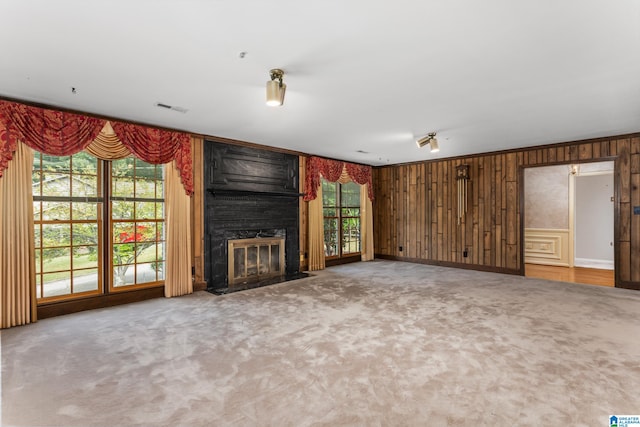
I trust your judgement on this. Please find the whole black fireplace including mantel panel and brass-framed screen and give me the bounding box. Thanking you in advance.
[202,141,301,293]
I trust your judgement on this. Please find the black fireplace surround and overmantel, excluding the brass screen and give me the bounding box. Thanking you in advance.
[204,141,300,291]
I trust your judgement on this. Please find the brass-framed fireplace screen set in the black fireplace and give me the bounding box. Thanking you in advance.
[228,237,285,287]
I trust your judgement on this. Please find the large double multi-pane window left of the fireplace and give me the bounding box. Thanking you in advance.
[32,152,164,302]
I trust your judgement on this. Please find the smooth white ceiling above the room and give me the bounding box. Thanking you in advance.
[0,0,640,165]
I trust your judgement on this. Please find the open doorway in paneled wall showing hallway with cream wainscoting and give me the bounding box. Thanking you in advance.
[523,161,615,286]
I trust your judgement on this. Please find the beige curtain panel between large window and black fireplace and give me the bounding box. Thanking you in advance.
[164,162,193,297]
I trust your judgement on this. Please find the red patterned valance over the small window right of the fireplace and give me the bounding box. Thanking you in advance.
[304,156,373,201]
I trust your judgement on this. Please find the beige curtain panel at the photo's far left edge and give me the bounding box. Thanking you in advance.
[0,142,37,328]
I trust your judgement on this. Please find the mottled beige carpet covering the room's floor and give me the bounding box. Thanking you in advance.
[1,261,640,426]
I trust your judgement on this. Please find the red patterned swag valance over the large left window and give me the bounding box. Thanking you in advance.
[0,100,193,195]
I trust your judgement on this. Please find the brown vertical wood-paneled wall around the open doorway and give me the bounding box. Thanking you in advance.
[374,134,640,289]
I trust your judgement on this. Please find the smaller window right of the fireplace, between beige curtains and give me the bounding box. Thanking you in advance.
[322,179,360,258]
